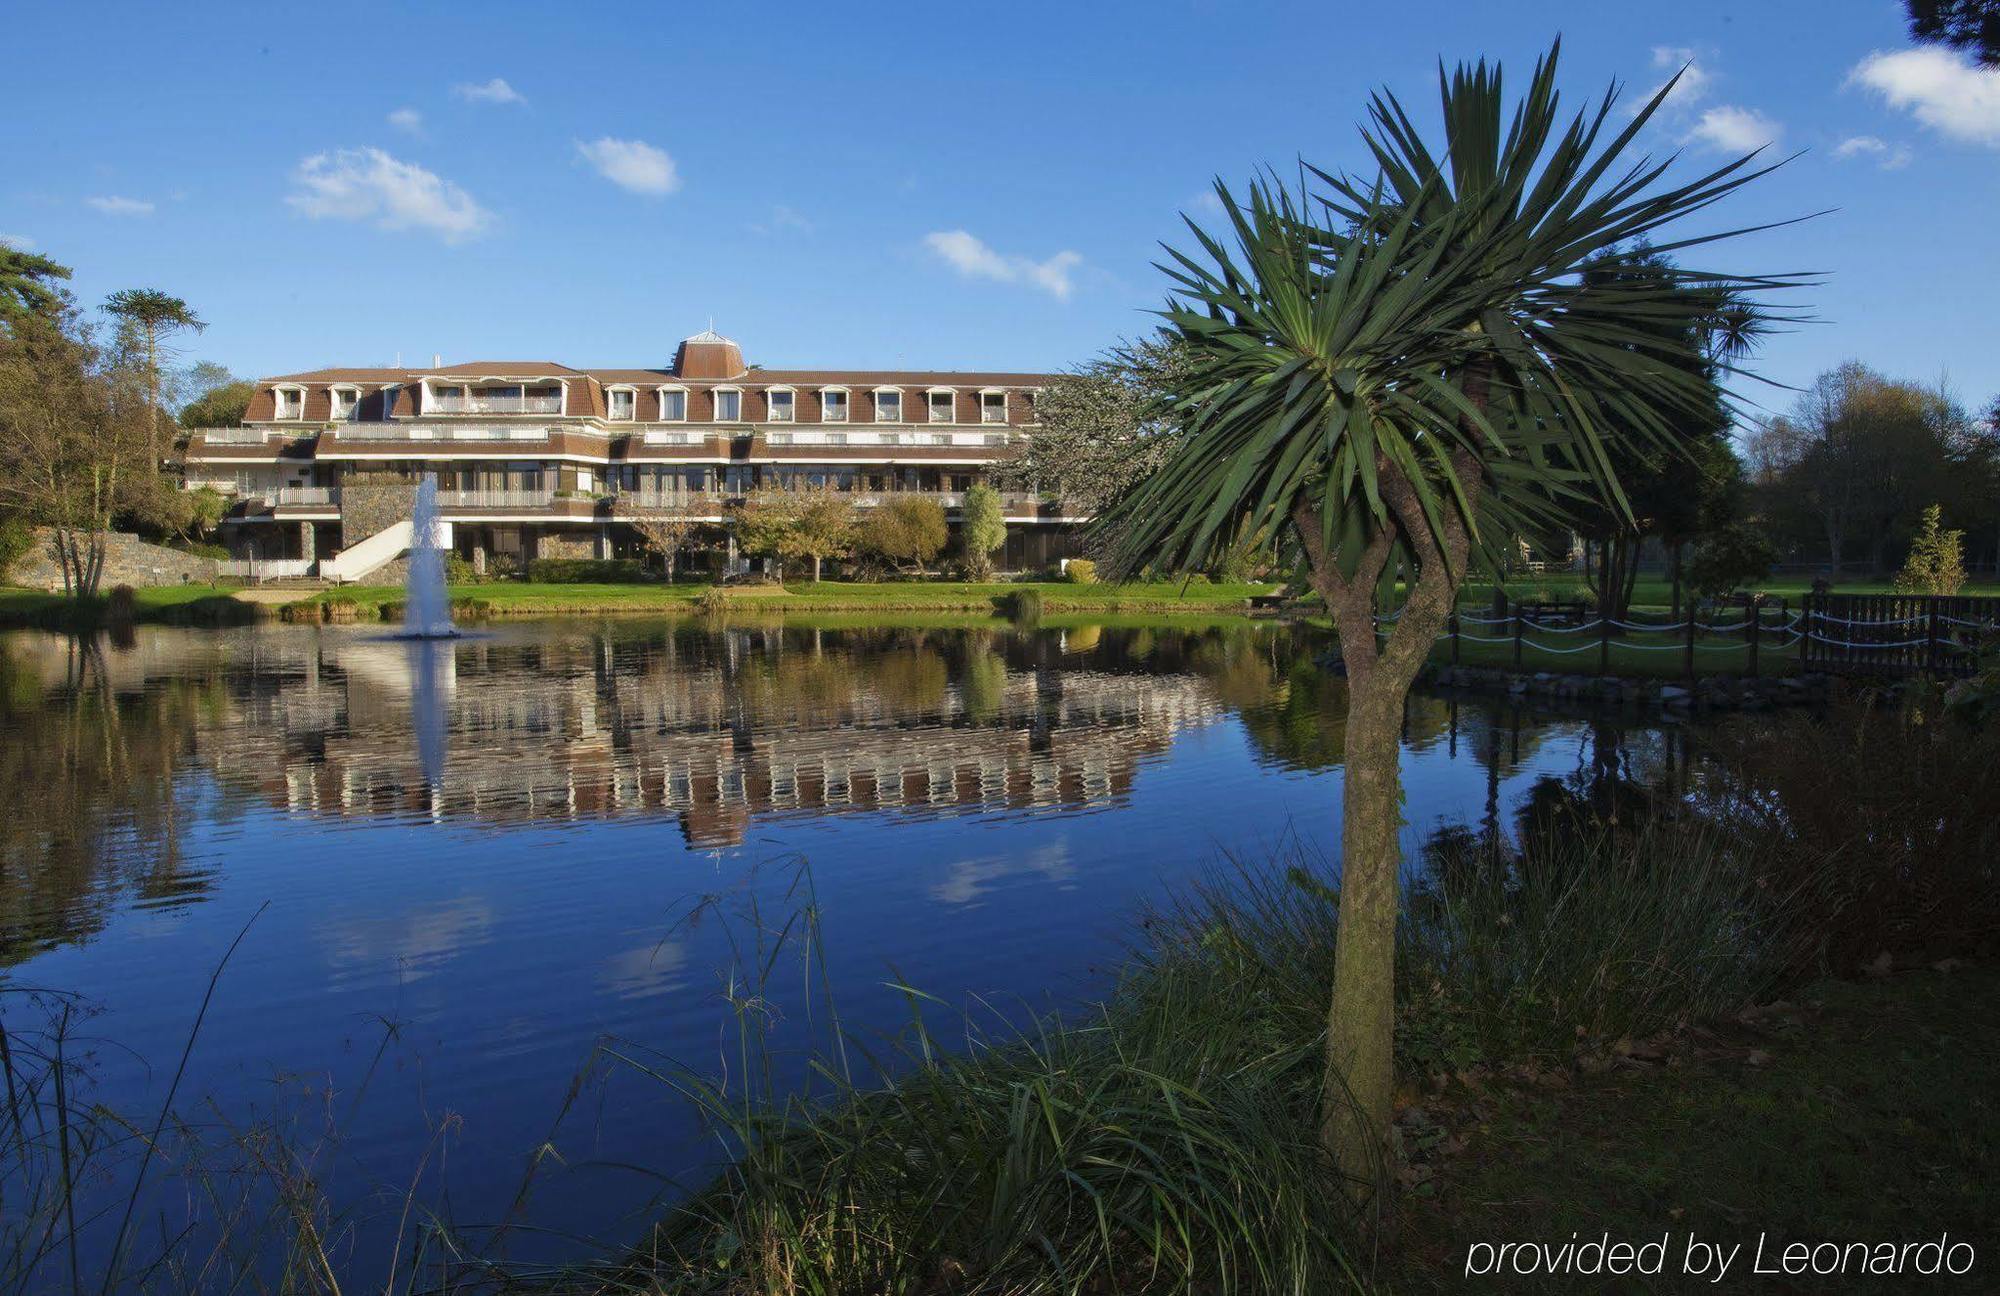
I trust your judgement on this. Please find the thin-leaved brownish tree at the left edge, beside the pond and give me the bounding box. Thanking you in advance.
[0,308,164,598]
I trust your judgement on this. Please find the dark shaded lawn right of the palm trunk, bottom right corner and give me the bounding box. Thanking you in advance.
[1382,968,2000,1292]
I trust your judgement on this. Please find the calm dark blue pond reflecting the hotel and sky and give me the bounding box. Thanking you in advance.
[0,620,1688,1252]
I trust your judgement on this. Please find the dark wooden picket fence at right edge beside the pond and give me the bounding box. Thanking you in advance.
[1800,594,2000,678]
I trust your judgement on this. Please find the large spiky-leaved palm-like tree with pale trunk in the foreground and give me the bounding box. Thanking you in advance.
[1106,50,1792,1196]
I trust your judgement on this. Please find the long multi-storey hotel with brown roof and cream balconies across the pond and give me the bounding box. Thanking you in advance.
[186,332,1084,580]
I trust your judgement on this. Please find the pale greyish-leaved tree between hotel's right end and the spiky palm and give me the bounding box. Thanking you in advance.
[994,334,1184,518]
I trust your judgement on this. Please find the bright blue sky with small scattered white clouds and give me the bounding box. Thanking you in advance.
[0,0,2000,416]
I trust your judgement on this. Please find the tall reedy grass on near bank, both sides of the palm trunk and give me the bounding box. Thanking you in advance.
[600,826,1824,1296]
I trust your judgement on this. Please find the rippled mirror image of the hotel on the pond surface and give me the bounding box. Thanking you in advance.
[168,632,1224,846]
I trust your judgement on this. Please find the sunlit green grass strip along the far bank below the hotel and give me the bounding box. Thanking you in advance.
[274,580,1272,620]
